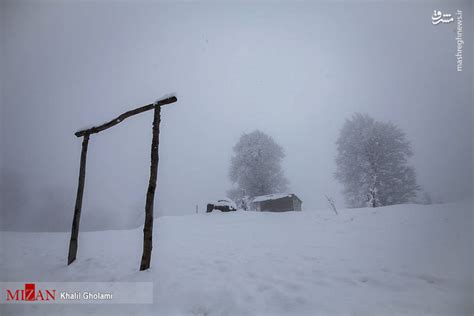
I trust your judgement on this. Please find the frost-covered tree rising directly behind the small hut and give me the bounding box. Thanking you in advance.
[228,130,288,201]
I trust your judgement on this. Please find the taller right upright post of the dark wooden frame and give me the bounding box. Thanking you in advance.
[140,106,161,271]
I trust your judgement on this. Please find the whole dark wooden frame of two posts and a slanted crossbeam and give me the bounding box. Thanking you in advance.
[67,96,178,271]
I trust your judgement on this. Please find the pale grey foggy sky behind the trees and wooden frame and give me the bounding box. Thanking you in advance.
[0,1,473,230]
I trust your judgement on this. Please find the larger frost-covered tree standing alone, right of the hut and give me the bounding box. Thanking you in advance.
[336,114,419,207]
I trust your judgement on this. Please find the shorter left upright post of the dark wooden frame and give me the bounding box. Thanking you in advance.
[67,134,89,265]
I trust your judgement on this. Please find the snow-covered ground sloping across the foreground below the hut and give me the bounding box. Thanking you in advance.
[0,201,474,315]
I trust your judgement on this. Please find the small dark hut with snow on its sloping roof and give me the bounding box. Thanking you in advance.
[250,193,303,212]
